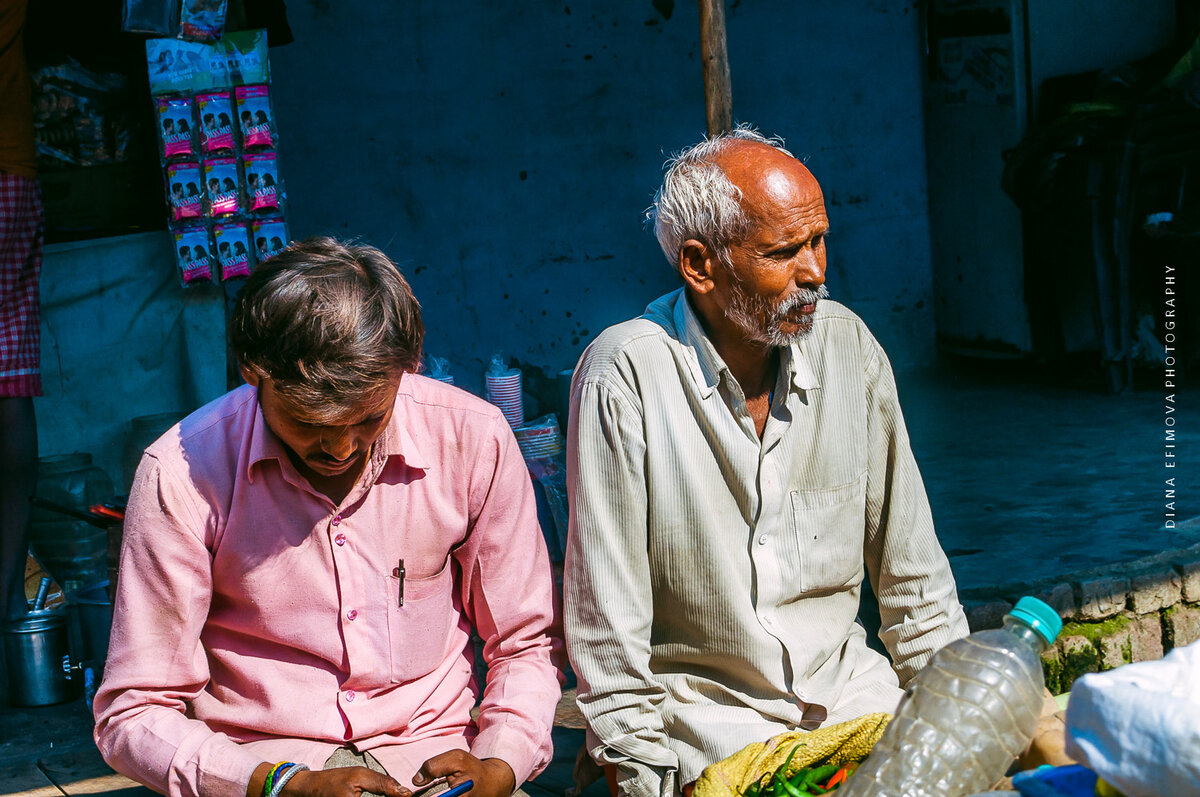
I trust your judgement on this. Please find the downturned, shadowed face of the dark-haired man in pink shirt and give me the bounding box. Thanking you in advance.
[242,370,401,479]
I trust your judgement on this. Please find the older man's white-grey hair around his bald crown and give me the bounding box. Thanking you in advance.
[646,124,794,268]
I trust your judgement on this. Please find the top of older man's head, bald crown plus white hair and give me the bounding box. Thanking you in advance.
[647,125,823,268]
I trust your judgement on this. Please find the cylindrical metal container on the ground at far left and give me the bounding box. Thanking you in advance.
[4,610,83,706]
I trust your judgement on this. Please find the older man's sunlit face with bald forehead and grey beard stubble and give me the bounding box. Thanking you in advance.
[720,145,829,346]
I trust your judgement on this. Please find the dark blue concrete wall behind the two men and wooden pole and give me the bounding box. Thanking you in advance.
[271,0,932,388]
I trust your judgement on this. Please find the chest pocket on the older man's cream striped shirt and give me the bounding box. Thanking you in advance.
[792,473,866,593]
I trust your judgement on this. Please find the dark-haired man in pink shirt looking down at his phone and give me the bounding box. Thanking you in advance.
[95,239,562,797]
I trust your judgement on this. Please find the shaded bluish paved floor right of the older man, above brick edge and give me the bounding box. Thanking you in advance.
[898,364,1200,587]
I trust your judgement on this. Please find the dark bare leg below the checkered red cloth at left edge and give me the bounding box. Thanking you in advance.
[0,397,37,617]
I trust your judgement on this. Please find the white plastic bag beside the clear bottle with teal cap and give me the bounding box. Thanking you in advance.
[1067,642,1200,797]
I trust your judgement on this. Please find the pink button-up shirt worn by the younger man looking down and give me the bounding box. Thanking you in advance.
[95,374,562,797]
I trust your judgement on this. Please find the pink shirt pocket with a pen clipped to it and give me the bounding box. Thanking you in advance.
[384,557,457,683]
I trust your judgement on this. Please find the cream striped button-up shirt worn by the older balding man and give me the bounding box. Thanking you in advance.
[565,289,967,797]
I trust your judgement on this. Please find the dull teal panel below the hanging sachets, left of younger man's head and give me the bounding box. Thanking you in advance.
[34,232,226,493]
